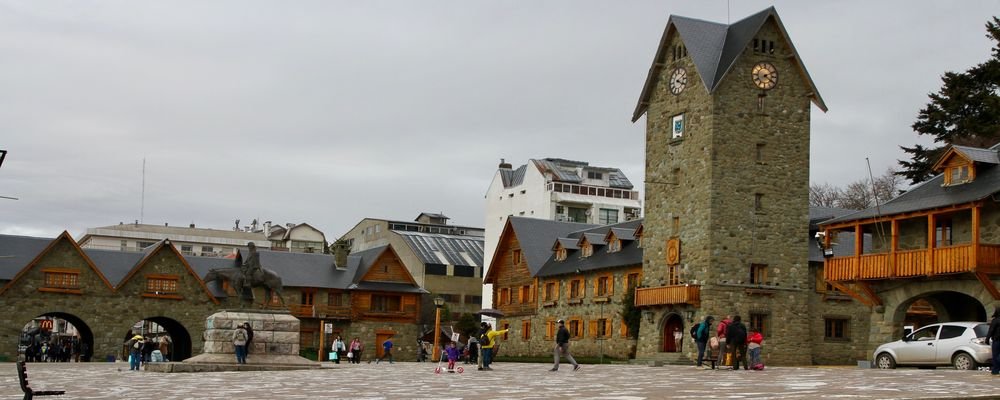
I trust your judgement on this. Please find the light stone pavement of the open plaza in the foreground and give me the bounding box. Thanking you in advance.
[0,359,1000,400]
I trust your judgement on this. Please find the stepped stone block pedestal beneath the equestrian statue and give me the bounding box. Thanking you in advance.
[147,310,321,372]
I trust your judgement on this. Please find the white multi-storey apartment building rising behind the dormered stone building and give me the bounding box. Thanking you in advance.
[485,158,642,265]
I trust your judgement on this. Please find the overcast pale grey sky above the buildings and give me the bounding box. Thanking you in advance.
[0,0,1000,241]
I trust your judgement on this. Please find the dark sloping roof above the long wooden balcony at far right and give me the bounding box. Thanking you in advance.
[822,144,1000,225]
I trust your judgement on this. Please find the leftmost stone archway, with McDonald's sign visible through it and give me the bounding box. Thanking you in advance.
[18,312,94,362]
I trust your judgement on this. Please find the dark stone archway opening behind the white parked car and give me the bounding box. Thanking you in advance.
[894,291,987,337]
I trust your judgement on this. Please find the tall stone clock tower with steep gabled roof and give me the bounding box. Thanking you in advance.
[633,7,826,363]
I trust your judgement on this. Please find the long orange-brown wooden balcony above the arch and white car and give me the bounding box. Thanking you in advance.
[824,244,1000,280]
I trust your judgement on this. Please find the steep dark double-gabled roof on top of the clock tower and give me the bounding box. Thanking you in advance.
[632,7,826,122]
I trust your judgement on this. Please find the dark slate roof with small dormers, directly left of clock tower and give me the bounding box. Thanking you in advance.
[536,219,643,277]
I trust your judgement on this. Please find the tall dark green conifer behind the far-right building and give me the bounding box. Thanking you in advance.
[899,17,1000,183]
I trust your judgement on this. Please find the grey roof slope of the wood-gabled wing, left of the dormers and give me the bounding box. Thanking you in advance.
[507,217,599,276]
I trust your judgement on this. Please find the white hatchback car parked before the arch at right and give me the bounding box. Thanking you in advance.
[873,322,992,369]
